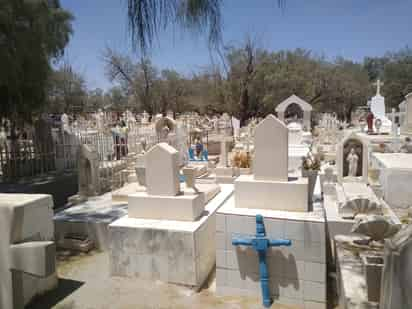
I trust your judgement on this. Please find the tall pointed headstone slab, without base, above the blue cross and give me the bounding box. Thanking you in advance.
[253,114,288,181]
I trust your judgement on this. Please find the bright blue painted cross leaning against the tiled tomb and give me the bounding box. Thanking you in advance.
[232,215,292,308]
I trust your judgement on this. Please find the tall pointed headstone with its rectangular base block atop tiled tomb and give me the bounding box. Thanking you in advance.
[235,115,308,211]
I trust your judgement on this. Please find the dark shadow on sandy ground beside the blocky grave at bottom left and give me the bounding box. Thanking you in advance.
[25,279,84,309]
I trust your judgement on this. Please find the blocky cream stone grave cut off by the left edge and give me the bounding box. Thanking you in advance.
[0,194,57,309]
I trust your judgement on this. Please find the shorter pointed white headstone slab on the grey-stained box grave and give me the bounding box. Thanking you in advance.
[145,143,180,196]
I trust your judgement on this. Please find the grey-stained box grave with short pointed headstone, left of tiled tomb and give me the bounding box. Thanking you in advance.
[109,143,232,288]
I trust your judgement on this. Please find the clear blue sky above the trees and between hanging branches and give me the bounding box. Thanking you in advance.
[61,0,412,90]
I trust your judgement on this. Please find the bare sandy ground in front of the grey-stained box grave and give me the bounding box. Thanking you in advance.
[26,250,337,309]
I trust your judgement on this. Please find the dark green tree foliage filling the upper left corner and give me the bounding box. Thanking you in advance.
[0,0,73,119]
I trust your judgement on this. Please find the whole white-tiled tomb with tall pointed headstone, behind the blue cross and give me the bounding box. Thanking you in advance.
[216,115,326,308]
